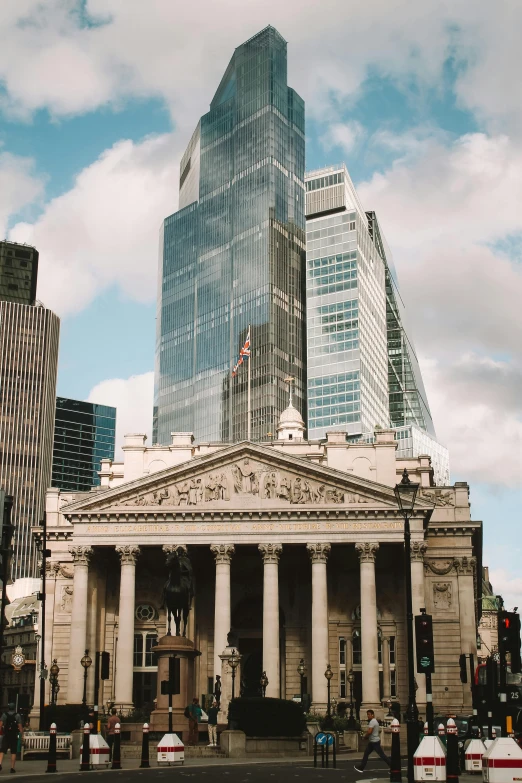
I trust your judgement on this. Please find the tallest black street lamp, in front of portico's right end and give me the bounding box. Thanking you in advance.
[394,468,419,783]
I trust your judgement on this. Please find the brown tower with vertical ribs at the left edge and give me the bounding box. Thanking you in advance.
[0,301,60,579]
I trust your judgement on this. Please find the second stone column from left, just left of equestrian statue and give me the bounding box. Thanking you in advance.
[114,544,140,712]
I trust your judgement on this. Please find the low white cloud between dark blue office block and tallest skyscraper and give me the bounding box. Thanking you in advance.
[87,372,154,460]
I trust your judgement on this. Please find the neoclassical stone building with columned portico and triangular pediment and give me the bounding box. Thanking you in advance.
[35,404,482,724]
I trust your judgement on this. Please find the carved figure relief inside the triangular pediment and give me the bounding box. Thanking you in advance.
[116,457,370,507]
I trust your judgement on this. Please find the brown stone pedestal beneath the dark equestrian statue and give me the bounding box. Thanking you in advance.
[150,636,201,742]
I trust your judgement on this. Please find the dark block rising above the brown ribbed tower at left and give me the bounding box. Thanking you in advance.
[0,240,38,305]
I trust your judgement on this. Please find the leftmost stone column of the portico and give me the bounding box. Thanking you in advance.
[67,546,93,704]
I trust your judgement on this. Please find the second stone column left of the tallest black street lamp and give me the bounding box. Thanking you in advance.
[306,543,332,710]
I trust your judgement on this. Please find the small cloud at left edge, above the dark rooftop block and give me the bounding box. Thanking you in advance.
[0,152,44,239]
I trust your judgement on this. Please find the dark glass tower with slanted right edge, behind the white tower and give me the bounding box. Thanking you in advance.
[366,212,434,434]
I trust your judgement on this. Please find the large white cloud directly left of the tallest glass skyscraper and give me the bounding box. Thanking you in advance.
[6,134,179,315]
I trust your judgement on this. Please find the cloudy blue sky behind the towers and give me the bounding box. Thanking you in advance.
[0,0,522,608]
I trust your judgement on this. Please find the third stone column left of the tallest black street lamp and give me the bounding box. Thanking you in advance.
[256,544,283,699]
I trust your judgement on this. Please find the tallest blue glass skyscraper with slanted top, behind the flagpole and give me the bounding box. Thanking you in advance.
[153,27,306,443]
